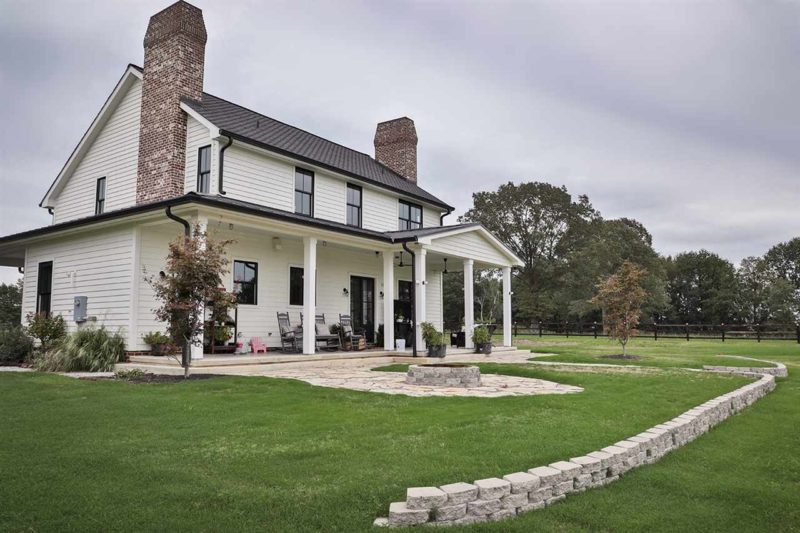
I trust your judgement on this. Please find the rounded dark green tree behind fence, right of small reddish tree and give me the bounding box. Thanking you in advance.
[667,250,737,324]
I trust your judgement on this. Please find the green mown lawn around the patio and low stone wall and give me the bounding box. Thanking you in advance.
[0,341,800,531]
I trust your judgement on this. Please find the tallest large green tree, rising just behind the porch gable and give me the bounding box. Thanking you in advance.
[459,182,600,321]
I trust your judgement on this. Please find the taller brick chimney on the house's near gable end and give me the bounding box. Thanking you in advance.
[136,0,207,204]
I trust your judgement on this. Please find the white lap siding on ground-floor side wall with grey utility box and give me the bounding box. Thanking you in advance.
[23,228,133,337]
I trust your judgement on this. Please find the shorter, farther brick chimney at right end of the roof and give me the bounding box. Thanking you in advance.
[375,117,417,183]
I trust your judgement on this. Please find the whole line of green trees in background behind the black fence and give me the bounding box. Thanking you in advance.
[444,182,800,329]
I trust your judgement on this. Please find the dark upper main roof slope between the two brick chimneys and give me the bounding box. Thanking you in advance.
[184,93,453,211]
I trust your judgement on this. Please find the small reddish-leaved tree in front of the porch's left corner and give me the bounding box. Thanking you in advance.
[145,225,236,376]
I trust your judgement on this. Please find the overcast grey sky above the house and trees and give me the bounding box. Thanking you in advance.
[0,0,800,281]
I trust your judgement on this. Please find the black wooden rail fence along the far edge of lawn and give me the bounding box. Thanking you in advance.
[514,322,800,344]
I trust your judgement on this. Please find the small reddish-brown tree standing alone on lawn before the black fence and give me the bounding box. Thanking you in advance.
[591,261,647,356]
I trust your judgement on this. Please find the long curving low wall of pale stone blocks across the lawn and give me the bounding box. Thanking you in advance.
[375,363,786,527]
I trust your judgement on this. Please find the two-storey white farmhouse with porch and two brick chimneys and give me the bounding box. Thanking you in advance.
[0,1,521,357]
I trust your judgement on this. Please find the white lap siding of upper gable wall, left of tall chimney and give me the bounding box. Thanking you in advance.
[54,81,142,223]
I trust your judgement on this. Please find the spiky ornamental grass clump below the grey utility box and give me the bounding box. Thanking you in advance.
[34,327,125,372]
